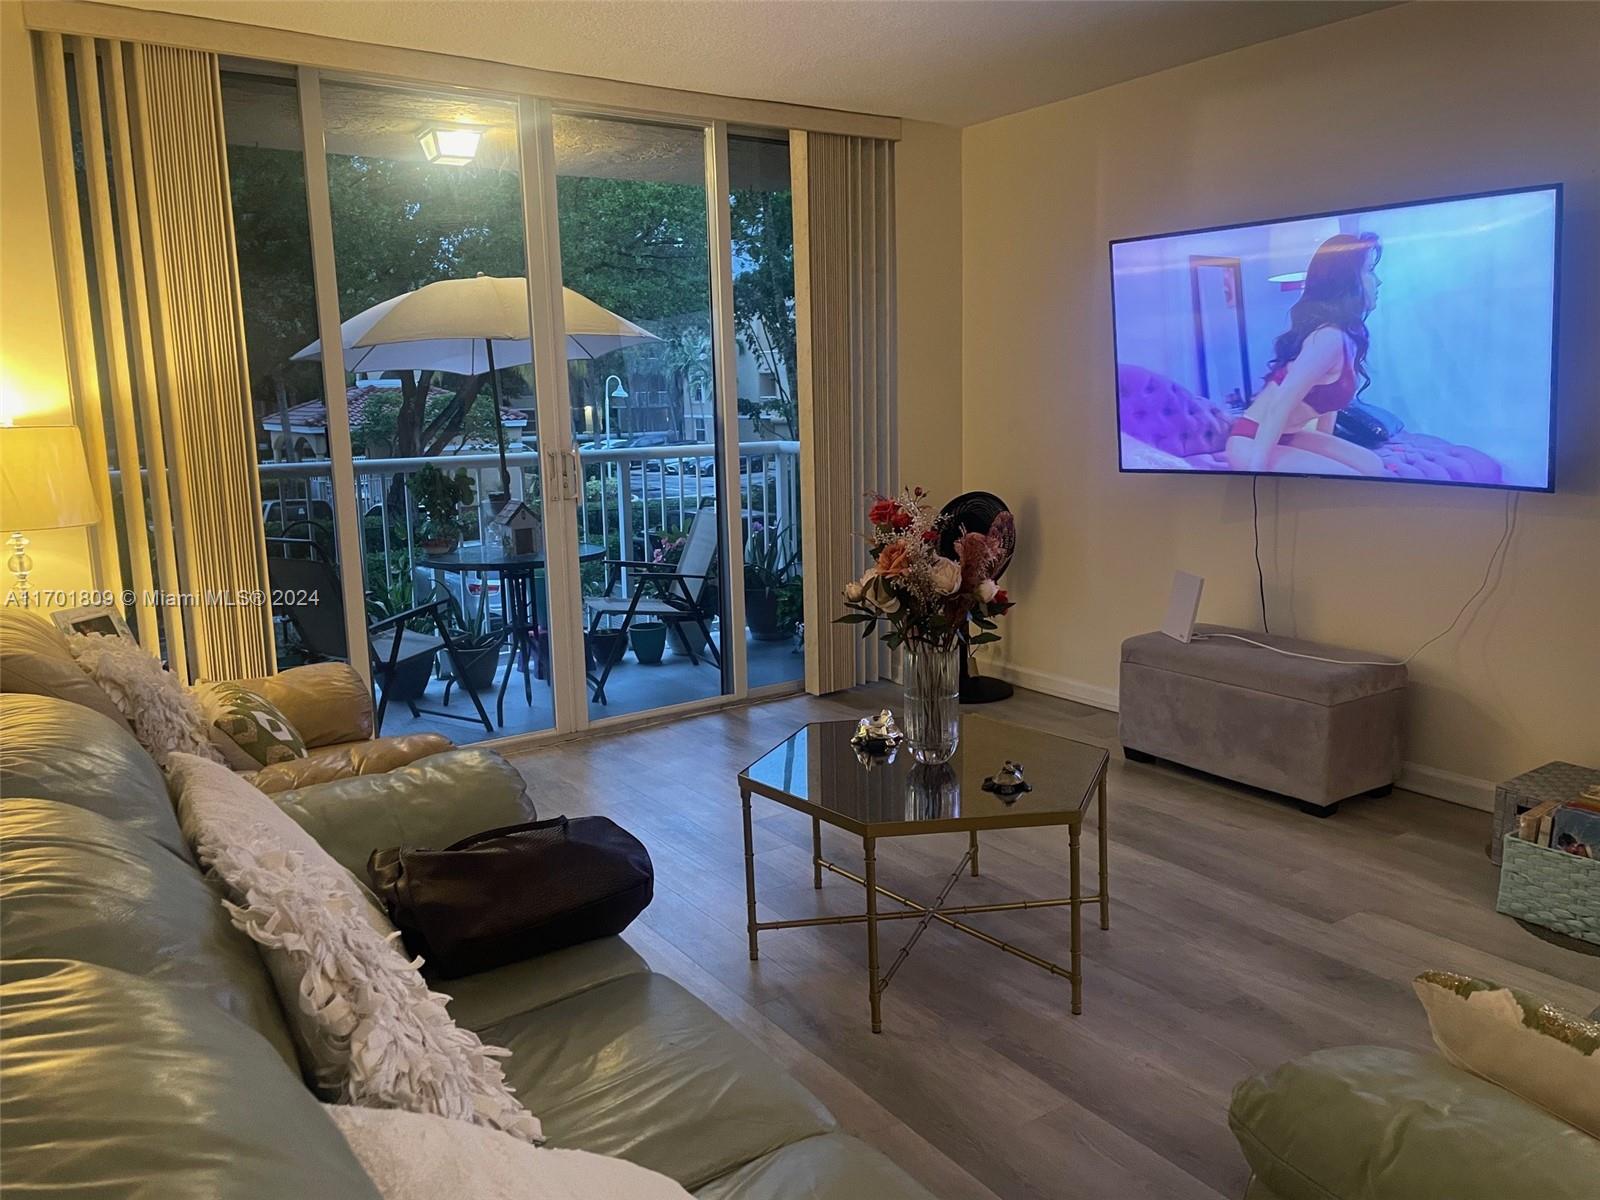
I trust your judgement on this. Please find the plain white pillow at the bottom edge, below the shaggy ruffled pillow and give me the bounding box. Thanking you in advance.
[325,1104,690,1200]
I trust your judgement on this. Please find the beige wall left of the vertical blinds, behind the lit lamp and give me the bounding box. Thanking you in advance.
[0,0,91,606]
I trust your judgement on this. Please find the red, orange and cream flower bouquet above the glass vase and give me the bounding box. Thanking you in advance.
[838,488,1016,650]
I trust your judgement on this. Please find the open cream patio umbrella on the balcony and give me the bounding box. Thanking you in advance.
[294,275,658,491]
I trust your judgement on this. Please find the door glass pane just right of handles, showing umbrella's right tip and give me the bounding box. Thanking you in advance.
[552,114,733,718]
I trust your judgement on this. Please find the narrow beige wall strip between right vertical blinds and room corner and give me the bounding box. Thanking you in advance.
[894,122,962,502]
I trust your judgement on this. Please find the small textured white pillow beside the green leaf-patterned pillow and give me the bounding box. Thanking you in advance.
[67,634,222,766]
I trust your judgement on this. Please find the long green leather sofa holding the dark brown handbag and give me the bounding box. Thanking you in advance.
[0,694,928,1200]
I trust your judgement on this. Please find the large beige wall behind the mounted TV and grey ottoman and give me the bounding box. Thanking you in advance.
[962,3,1600,800]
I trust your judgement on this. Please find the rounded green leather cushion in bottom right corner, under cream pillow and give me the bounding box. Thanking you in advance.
[1229,1046,1600,1200]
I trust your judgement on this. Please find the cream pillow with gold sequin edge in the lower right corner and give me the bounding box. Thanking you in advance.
[1411,971,1600,1138]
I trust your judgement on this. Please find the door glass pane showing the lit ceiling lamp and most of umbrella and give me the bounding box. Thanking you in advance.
[322,80,555,741]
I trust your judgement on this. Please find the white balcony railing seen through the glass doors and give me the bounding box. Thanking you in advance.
[261,440,800,604]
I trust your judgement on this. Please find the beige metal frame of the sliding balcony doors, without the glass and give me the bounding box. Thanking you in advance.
[296,66,777,747]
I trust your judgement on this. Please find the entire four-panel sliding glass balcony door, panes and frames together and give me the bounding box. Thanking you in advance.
[224,64,803,752]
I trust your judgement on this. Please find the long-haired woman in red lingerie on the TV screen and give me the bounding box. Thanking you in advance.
[1224,234,1384,475]
